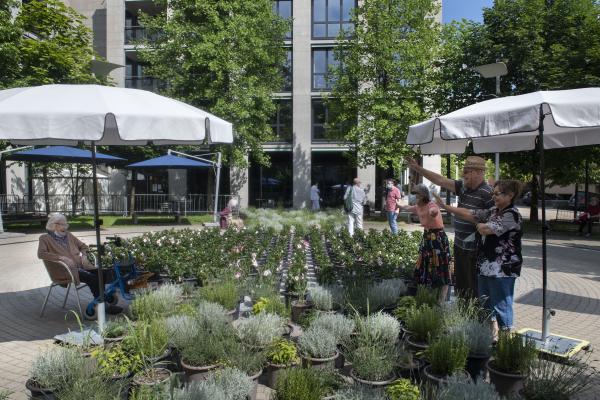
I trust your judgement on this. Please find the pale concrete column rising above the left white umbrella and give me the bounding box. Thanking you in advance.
[106,0,125,87]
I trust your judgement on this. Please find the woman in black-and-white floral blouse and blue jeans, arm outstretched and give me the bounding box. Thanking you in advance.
[436,180,523,336]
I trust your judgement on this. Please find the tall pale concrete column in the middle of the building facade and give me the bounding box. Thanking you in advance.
[292,0,312,208]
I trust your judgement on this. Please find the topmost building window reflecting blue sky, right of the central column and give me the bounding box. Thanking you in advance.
[312,0,356,39]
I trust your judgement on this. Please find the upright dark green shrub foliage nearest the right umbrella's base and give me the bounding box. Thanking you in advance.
[492,332,537,375]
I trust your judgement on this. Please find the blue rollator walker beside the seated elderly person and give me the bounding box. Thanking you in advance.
[85,236,140,320]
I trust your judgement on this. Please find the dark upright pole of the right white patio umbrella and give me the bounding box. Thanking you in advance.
[538,104,552,342]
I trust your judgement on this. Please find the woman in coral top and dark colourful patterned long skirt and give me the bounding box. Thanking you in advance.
[400,184,451,300]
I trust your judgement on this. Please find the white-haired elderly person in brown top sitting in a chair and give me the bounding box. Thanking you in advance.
[38,213,123,314]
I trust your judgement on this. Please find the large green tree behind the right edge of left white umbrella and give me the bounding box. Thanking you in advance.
[139,0,289,165]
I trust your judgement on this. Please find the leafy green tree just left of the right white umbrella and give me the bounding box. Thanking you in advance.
[328,0,439,168]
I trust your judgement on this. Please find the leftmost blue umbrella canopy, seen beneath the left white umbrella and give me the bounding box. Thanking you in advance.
[6,146,125,164]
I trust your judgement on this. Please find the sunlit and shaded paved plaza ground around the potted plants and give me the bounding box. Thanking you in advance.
[0,222,600,400]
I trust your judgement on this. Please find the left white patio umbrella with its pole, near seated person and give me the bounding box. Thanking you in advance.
[0,85,233,329]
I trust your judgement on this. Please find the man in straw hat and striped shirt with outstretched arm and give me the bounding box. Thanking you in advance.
[406,156,494,298]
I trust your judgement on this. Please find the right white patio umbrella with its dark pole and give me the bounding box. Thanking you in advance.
[406,88,600,341]
